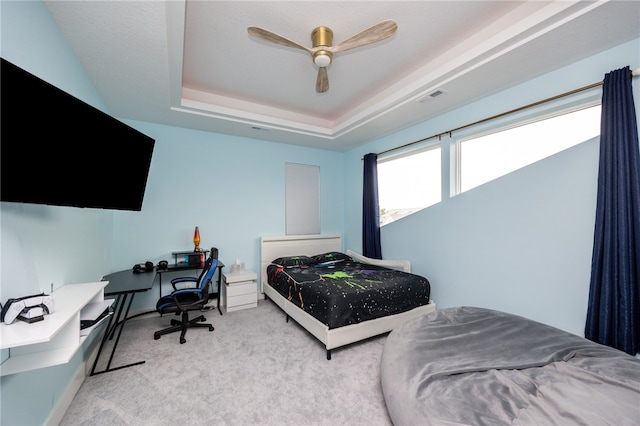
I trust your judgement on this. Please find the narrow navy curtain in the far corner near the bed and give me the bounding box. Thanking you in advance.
[362,154,382,259]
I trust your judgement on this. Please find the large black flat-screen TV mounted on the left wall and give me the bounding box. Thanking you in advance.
[0,58,155,211]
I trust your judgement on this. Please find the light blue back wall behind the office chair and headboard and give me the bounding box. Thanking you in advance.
[112,121,344,310]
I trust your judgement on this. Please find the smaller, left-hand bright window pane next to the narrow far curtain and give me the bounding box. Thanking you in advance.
[378,145,442,226]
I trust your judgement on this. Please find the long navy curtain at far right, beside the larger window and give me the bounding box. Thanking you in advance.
[585,67,640,355]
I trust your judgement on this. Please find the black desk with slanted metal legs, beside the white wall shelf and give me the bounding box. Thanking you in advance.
[90,269,156,376]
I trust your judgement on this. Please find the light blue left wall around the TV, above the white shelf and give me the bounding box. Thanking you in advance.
[0,1,113,294]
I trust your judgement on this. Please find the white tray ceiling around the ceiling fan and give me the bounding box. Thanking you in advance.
[47,0,640,151]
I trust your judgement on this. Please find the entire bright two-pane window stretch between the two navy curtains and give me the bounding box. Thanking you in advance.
[378,102,600,226]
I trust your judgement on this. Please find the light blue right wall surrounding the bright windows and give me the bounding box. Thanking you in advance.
[345,39,640,335]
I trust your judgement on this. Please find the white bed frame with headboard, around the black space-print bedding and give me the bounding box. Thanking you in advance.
[260,234,436,359]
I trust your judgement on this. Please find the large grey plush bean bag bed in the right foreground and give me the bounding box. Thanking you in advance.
[381,307,640,426]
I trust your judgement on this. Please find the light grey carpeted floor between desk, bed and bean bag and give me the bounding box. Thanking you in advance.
[61,300,391,426]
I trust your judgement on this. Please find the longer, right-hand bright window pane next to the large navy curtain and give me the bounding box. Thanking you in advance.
[457,105,600,193]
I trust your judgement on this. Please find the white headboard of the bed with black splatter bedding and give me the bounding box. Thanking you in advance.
[260,234,343,292]
